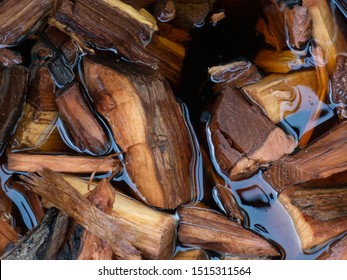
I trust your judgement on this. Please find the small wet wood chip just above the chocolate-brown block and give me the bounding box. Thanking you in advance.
[208,60,262,91]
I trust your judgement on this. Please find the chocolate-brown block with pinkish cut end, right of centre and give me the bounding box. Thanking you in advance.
[210,88,296,180]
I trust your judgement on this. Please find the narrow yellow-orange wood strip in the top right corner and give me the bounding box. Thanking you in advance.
[303,0,347,74]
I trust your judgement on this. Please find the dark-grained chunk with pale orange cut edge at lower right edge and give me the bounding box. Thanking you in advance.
[278,185,347,252]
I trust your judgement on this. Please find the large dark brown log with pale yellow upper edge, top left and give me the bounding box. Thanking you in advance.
[51,0,185,84]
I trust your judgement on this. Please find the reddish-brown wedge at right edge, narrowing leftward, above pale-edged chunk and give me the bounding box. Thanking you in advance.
[263,123,347,192]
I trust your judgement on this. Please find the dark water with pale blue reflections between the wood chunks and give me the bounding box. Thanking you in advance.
[0,0,347,259]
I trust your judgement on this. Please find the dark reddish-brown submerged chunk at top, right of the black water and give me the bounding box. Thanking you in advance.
[256,3,287,51]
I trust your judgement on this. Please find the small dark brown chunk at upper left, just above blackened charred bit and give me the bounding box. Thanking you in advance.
[44,26,78,64]
